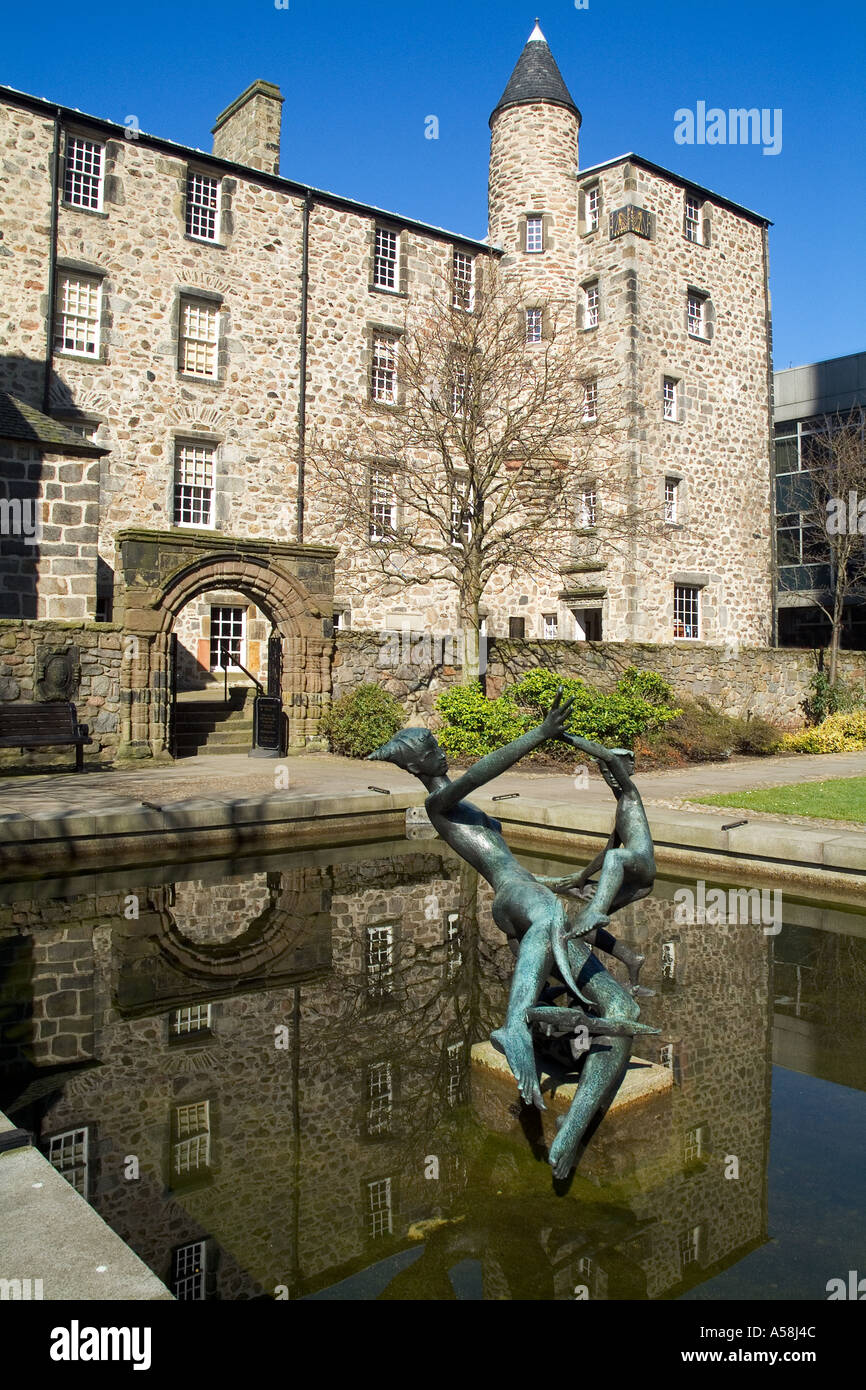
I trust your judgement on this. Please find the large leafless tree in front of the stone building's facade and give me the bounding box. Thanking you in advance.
[310,259,635,680]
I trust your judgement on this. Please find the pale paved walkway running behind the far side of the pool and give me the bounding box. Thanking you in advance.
[0,752,866,816]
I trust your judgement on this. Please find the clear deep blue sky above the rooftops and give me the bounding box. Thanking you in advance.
[0,0,866,367]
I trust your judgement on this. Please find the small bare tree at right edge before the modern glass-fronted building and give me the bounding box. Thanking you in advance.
[795,406,866,685]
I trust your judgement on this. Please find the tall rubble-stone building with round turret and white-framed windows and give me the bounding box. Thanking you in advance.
[0,28,771,746]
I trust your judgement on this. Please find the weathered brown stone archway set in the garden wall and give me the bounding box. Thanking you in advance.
[115,531,336,758]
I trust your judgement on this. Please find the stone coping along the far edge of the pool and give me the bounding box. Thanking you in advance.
[0,790,866,891]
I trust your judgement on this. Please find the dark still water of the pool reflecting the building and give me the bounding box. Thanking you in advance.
[0,841,866,1300]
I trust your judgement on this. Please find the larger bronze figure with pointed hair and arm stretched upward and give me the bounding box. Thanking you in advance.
[370,689,656,1177]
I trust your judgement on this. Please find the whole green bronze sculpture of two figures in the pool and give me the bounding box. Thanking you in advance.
[370,692,655,1177]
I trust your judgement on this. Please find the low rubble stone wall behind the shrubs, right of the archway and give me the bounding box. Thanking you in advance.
[334,631,866,728]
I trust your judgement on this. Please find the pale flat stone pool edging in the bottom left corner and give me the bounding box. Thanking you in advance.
[0,1113,174,1302]
